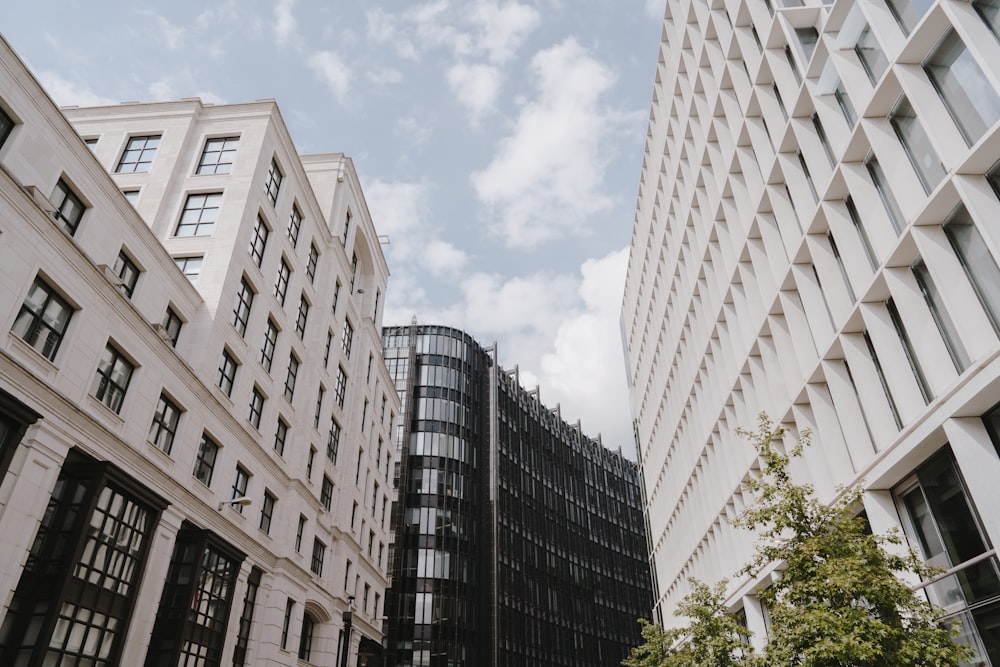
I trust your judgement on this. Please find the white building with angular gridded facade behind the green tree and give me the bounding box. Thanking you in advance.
[623,0,1000,665]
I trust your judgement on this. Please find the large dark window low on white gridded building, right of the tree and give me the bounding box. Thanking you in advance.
[896,450,1000,665]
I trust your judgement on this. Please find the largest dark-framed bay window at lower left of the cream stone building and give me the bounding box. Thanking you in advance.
[0,449,163,665]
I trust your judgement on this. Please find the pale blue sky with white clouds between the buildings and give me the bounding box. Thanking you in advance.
[7,0,664,459]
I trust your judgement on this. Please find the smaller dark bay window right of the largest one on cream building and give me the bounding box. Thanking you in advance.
[146,522,244,667]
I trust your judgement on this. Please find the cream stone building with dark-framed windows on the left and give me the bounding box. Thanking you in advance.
[0,36,399,666]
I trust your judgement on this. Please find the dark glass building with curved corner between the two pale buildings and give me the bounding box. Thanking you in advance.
[383,324,651,667]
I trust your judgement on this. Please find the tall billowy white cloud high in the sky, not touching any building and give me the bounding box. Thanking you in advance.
[472,39,621,247]
